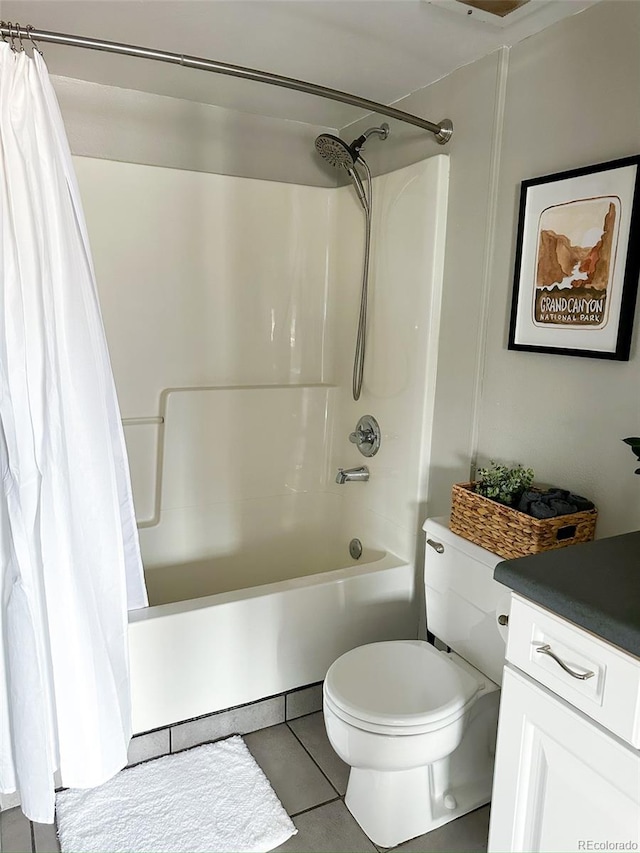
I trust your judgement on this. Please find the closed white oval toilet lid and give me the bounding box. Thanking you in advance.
[324,640,480,726]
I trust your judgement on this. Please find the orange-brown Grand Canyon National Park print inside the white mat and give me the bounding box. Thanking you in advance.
[532,196,620,328]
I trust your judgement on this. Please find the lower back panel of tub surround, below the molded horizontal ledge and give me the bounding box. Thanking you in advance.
[136,384,337,560]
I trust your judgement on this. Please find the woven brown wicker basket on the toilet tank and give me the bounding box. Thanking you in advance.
[449,483,598,559]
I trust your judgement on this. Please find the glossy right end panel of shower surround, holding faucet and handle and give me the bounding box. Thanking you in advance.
[327,155,449,562]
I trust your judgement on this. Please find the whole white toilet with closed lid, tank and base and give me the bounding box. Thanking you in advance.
[323,519,510,847]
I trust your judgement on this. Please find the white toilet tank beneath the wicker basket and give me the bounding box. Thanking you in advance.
[423,518,511,684]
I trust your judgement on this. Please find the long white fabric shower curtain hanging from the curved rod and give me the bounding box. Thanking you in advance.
[0,42,147,823]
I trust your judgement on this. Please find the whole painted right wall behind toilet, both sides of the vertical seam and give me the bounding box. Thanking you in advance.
[348,0,640,536]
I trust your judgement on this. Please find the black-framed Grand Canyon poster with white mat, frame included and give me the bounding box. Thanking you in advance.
[509,155,640,361]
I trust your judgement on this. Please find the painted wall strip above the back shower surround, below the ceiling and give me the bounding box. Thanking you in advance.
[57,76,337,187]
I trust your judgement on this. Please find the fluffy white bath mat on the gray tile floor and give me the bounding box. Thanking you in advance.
[56,736,298,853]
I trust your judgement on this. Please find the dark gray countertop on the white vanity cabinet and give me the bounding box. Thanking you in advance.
[494,531,640,657]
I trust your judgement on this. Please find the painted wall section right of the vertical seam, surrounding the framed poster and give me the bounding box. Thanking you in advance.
[478,0,640,536]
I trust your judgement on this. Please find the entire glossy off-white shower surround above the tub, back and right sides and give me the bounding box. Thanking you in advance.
[76,155,449,570]
